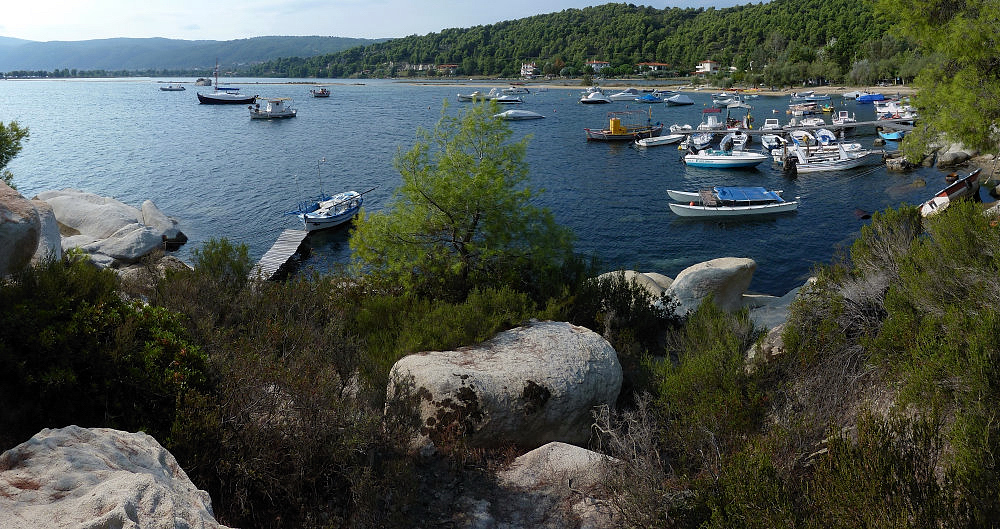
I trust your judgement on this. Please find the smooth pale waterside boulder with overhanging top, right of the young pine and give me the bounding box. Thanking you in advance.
[667,257,757,315]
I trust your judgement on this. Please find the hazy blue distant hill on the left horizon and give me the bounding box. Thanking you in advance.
[0,36,387,72]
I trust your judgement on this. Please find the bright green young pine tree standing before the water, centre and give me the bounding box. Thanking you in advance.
[351,103,571,299]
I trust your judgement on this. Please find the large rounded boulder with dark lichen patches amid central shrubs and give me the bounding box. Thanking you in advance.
[389,321,622,448]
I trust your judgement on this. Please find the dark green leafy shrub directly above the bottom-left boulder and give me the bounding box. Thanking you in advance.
[0,253,208,449]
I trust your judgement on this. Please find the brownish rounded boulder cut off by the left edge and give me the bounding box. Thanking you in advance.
[0,182,41,276]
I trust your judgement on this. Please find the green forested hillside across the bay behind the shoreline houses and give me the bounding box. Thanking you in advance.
[246,0,888,82]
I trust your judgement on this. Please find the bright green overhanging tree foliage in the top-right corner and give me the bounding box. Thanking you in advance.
[879,0,1000,154]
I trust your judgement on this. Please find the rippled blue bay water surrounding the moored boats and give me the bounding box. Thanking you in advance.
[0,79,968,294]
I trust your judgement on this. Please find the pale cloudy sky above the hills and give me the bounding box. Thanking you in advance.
[0,0,759,41]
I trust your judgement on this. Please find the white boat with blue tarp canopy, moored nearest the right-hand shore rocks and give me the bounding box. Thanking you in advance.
[667,186,799,217]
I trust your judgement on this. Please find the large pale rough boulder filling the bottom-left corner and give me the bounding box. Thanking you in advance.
[0,426,232,529]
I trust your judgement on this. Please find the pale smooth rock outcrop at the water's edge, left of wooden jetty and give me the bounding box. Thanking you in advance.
[36,189,187,267]
